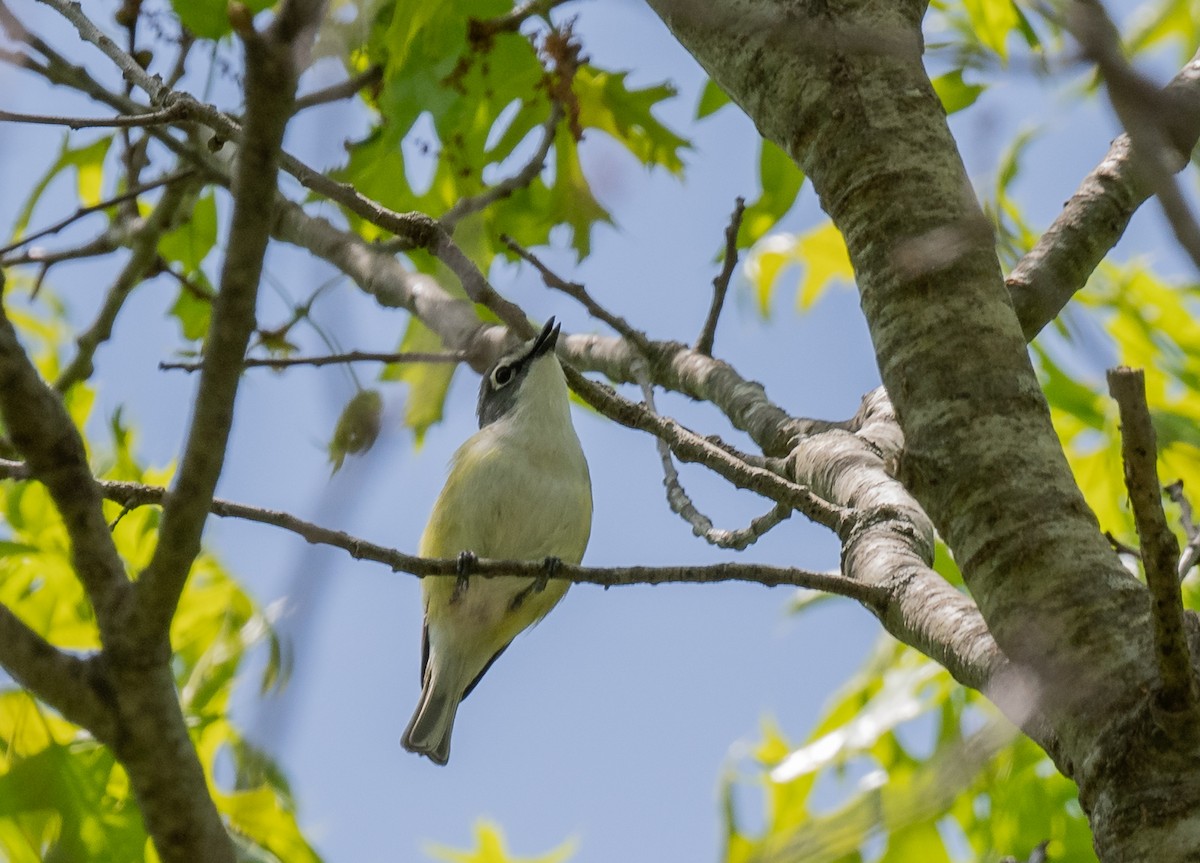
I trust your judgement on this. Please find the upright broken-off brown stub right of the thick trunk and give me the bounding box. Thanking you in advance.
[1108,366,1198,714]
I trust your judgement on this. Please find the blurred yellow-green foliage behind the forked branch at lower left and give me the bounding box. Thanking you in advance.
[0,295,319,863]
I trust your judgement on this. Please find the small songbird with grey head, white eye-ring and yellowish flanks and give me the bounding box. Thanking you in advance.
[401,318,592,765]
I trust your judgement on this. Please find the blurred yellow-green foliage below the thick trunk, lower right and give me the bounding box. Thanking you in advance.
[721,636,1096,863]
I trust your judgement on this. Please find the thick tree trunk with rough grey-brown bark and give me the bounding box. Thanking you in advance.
[650,0,1200,861]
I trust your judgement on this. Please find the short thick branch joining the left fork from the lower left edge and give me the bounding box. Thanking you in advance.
[0,605,115,742]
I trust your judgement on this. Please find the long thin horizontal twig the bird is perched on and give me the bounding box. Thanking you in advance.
[0,460,886,607]
